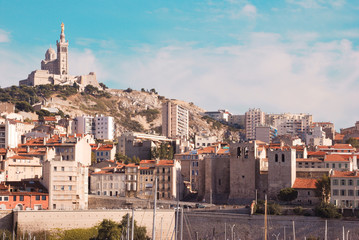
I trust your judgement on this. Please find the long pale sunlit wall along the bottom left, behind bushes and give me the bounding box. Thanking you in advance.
[13,209,175,239]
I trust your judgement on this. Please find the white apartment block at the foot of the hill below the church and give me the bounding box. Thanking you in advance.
[72,115,115,140]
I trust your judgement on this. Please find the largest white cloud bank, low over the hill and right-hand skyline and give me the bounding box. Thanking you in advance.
[106,33,359,127]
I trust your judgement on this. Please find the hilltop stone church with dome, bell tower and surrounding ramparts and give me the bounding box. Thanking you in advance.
[19,23,101,90]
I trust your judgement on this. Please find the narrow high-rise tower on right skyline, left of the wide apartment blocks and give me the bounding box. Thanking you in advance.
[245,108,265,140]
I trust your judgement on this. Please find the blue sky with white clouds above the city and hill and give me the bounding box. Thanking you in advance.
[0,0,359,129]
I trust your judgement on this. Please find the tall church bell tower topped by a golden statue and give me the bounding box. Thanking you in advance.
[56,23,69,75]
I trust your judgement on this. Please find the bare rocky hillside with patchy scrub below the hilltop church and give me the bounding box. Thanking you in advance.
[3,85,242,140]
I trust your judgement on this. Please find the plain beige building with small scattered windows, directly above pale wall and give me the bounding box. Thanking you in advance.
[42,156,88,210]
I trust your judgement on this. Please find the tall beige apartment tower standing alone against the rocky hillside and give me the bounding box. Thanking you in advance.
[162,102,189,138]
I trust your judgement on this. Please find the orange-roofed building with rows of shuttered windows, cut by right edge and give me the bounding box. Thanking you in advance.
[330,170,359,208]
